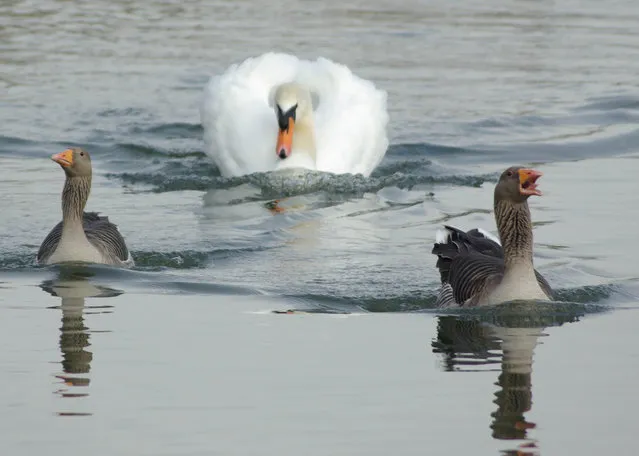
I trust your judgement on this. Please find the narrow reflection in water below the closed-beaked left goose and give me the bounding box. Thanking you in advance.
[40,266,123,416]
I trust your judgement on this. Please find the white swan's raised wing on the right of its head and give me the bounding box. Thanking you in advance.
[299,58,388,176]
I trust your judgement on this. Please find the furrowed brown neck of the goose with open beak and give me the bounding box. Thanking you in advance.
[495,201,534,274]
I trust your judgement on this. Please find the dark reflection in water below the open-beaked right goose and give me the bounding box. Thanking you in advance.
[431,309,580,456]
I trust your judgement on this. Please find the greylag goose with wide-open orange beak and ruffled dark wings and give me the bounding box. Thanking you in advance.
[432,167,552,307]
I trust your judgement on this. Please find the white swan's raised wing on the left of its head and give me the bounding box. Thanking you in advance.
[200,54,297,176]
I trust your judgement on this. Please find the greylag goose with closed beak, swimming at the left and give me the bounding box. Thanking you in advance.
[36,148,134,267]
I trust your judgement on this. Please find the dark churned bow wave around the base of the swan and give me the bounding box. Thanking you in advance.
[106,143,490,197]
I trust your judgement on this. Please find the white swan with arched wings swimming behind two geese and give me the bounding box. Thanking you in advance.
[200,53,388,176]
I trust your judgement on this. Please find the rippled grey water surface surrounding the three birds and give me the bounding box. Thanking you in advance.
[0,0,639,455]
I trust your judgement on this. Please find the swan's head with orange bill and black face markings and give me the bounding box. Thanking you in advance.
[275,83,313,159]
